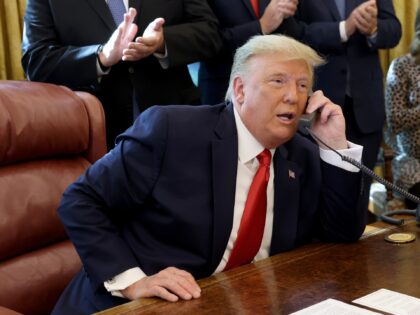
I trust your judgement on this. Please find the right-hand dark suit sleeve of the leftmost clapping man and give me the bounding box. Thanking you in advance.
[163,0,222,67]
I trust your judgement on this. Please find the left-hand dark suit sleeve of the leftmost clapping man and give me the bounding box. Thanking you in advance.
[22,0,99,89]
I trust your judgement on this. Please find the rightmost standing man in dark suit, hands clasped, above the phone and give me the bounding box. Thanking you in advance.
[295,0,401,216]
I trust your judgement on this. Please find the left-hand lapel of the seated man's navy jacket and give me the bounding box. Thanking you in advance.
[210,104,238,272]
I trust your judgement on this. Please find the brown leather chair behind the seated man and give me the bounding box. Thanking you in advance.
[0,81,106,315]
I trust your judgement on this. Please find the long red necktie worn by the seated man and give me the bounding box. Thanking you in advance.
[224,149,271,270]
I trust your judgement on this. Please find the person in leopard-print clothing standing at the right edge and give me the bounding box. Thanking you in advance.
[384,7,420,209]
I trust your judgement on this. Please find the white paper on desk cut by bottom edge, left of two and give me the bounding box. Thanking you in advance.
[290,299,380,315]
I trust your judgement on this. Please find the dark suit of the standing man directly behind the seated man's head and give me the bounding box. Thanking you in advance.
[198,0,302,105]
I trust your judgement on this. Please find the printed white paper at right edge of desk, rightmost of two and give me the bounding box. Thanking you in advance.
[353,289,420,315]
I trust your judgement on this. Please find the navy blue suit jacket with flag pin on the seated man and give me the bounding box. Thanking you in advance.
[56,104,366,314]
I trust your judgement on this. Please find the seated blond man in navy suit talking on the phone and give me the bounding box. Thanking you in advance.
[54,35,365,314]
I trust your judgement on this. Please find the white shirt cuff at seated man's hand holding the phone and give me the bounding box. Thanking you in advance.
[319,141,363,173]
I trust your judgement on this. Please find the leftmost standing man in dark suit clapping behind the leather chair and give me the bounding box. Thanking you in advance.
[22,0,221,148]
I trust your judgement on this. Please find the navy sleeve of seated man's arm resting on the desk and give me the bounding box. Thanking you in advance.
[58,108,167,288]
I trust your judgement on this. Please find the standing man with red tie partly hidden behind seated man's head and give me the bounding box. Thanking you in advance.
[198,0,303,105]
